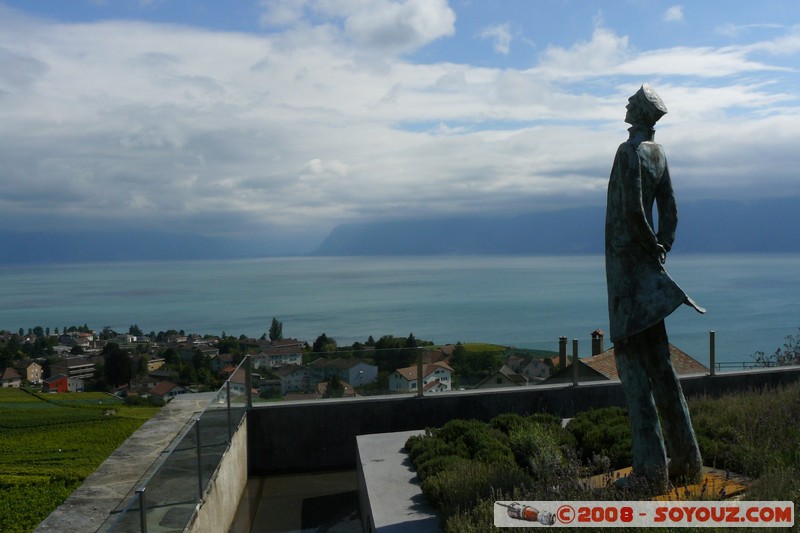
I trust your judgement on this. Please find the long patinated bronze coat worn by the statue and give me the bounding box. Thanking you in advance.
[606,131,687,342]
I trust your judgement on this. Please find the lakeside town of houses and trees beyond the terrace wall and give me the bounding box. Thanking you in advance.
[0,318,708,402]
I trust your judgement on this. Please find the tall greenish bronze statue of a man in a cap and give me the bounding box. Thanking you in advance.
[606,84,705,491]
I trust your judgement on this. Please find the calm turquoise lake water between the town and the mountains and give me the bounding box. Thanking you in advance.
[0,255,800,363]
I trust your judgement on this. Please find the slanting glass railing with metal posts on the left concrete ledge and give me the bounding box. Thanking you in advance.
[105,357,252,533]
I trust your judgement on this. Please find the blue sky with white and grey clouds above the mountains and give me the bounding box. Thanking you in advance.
[0,0,800,253]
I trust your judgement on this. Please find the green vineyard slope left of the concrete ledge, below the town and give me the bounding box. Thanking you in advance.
[0,388,158,532]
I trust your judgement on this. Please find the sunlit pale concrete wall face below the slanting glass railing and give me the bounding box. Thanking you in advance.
[184,418,248,533]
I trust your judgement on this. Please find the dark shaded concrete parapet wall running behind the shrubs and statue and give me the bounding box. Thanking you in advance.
[247,367,800,475]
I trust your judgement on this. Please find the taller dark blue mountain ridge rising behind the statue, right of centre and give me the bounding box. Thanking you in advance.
[312,198,800,256]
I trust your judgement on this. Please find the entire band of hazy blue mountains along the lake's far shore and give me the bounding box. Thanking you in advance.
[0,198,800,264]
